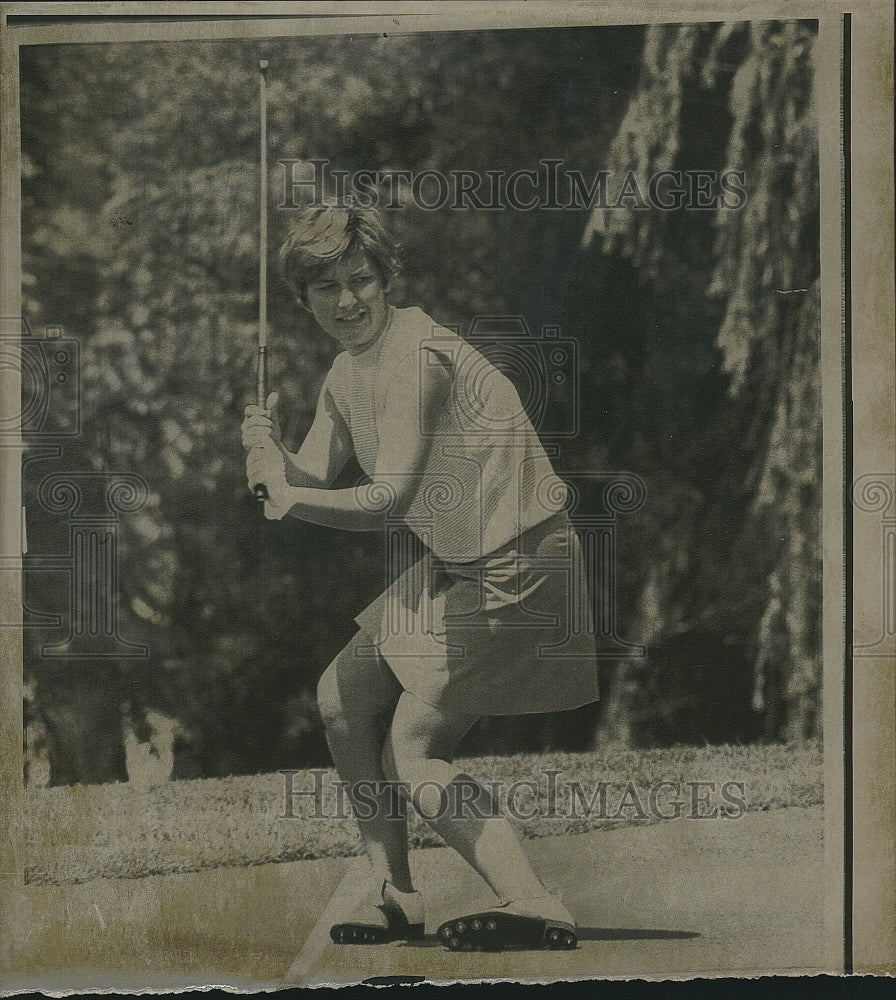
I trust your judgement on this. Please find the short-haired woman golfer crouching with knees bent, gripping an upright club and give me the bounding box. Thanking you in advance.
[242,197,598,950]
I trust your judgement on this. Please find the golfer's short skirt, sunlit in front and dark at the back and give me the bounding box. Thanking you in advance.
[355,514,598,716]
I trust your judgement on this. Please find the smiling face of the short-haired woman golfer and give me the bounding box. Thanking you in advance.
[306,249,389,354]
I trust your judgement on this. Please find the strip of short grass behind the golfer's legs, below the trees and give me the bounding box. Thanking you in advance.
[24,742,824,884]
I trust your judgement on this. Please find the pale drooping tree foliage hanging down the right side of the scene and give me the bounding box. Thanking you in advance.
[586,22,821,739]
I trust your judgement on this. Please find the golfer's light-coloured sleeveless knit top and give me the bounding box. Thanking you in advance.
[323,307,566,562]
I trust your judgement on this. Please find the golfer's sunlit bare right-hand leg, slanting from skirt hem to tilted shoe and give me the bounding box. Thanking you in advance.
[383,691,546,902]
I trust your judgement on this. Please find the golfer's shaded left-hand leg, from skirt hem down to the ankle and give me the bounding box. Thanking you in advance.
[317,632,413,892]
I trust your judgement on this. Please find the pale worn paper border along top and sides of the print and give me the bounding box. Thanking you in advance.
[0,0,896,989]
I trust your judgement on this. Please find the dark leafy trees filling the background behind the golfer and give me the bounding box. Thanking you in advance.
[21,22,821,784]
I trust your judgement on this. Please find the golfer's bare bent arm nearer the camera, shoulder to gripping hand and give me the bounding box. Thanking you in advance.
[247,353,451,531]
